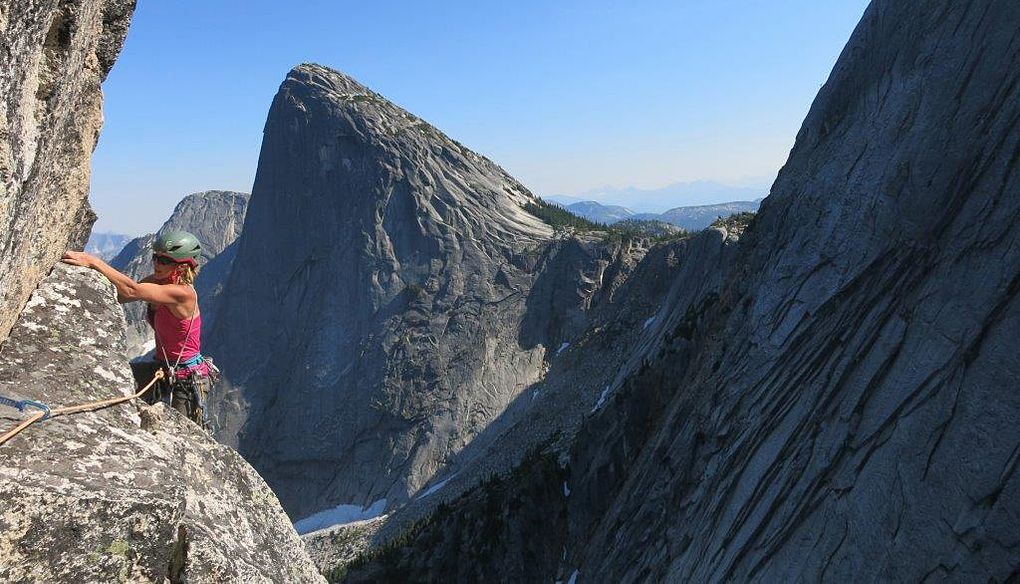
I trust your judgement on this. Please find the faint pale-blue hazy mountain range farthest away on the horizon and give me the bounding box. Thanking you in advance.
[543,180,769,213]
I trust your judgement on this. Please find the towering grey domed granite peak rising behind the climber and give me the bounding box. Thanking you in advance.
[207,65,567,518]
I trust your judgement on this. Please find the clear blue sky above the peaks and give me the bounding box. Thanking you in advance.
[91,0,867,234]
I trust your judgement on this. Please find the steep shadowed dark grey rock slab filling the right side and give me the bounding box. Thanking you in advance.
[340,0,1020,582]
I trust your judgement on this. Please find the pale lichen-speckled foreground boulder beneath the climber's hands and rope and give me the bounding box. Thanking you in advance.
[0,265,321,582]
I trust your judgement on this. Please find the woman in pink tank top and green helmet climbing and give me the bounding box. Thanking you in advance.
[63,231,210,425]
